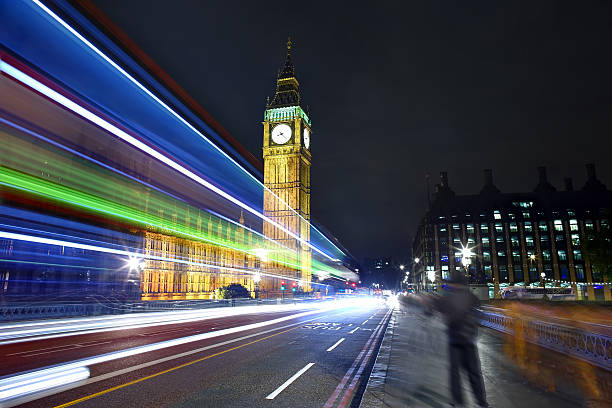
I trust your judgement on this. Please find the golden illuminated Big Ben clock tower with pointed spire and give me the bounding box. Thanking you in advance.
[263,40,312,292]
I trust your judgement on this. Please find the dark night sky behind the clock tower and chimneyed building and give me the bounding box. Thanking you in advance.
[94,0,612,258]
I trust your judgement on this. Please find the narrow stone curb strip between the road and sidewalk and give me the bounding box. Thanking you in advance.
[359,308,399,408]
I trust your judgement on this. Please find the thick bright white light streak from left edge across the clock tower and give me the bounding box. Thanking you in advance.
[0,60,339,262]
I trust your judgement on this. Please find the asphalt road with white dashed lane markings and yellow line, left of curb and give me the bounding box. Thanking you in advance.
[0,304,390,408]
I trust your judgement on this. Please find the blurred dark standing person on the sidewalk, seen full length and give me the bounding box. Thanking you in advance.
[436,272,489,407]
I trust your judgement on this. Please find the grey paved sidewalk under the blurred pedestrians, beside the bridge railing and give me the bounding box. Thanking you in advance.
[360,305,608,408]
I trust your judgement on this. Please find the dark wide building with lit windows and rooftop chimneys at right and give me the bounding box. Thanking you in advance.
[413,164,612,299]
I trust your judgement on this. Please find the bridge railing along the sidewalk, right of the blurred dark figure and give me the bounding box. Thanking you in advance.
[481,310,612,371]
